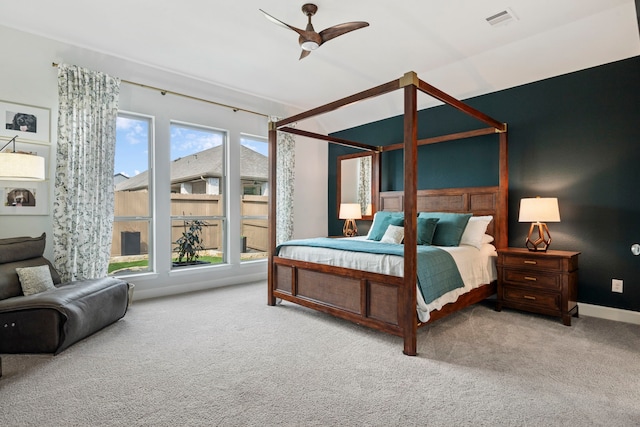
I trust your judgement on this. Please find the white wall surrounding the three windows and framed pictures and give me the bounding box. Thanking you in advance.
[0,26,327,298]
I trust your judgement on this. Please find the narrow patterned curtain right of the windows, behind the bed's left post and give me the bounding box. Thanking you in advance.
[274,119,296,245]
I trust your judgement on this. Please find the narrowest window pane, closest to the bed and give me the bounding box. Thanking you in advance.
[240,135,269,261]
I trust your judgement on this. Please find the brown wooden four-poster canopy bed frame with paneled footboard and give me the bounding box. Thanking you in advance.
[268,72,508,355]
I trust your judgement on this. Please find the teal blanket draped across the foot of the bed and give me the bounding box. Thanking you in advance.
[275,237,464,304]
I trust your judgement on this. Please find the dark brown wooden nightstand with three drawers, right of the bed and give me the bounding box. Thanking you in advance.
[496,248,580,326]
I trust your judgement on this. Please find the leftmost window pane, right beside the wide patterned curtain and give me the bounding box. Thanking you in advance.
[109,112,153,275]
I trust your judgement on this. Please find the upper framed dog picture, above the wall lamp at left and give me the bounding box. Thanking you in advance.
[0,100,51,143]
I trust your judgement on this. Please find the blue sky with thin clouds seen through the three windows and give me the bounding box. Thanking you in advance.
[114,116,267,177]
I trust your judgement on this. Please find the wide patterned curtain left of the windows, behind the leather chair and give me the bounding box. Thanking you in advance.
[53,64,120,281]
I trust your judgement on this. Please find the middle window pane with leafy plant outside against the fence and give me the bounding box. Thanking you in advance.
[170,122,227,268]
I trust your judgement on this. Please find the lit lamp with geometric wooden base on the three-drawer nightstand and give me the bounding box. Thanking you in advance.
[518,197,560,252]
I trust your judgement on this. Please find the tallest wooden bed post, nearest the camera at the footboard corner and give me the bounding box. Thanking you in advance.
[399,72,418,356]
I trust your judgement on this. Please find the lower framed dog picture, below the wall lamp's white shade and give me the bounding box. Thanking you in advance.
[0,181,49,215]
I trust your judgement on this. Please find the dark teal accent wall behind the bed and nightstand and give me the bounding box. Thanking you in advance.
[328,57,640,311]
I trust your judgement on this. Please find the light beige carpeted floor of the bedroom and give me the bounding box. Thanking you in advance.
[0,282,640,426]
